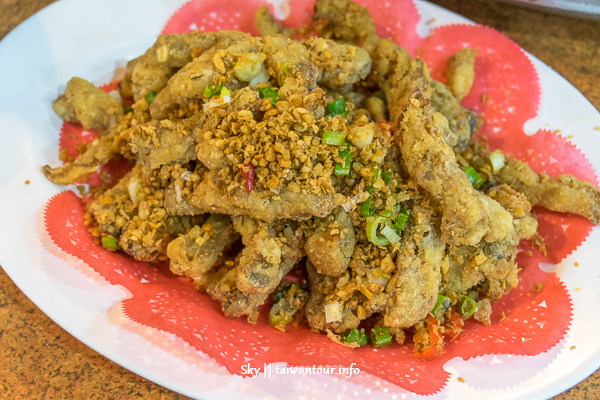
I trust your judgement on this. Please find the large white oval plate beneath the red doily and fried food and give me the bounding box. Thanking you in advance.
[0,0,600,399]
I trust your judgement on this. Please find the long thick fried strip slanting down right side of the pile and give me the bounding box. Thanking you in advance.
[398,88,514,245]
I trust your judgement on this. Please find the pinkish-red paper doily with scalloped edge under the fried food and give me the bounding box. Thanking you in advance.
[44,0,597,394]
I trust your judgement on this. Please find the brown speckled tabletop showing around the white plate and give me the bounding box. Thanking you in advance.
[0,0,600,400]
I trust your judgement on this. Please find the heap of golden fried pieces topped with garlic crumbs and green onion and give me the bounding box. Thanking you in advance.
[43,0,600,359]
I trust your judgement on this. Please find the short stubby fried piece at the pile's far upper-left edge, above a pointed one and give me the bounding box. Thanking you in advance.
[52,77,123,133]
